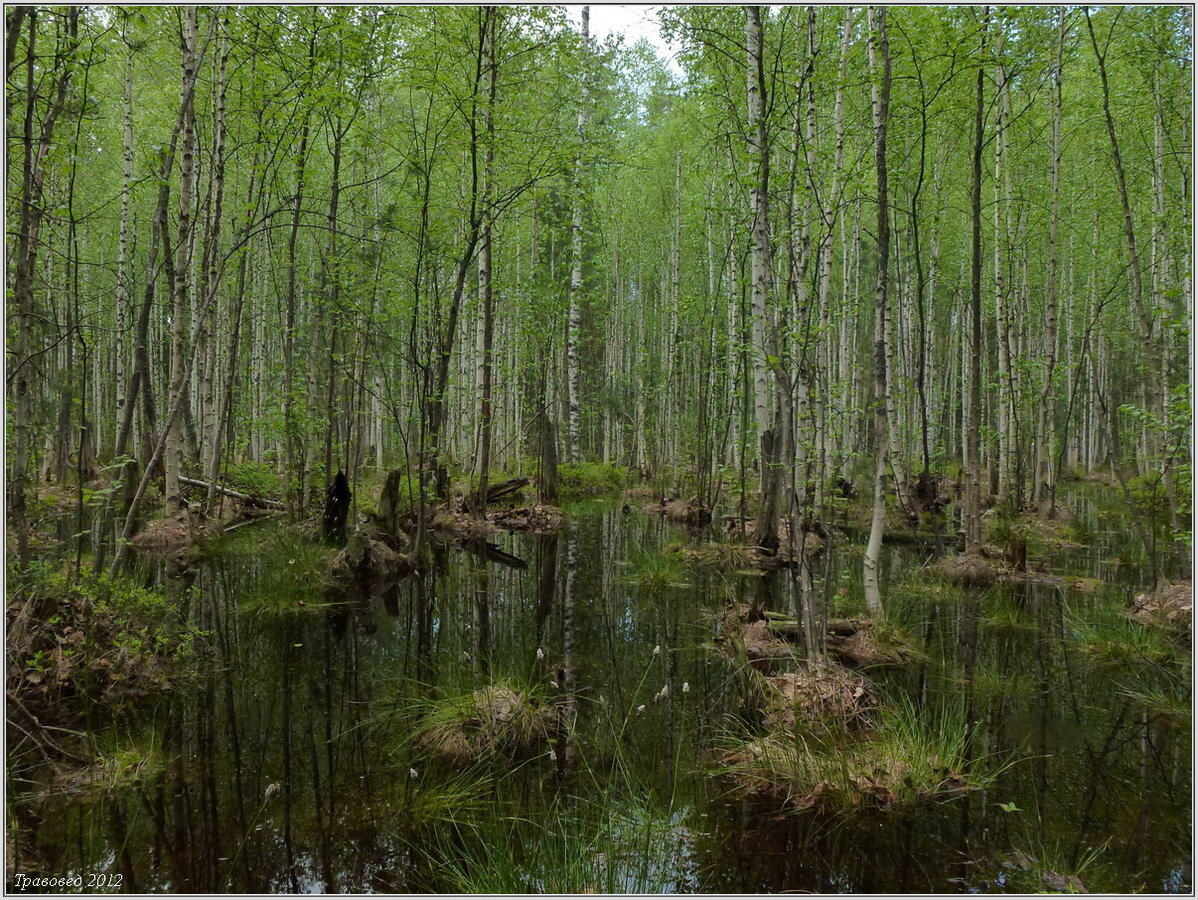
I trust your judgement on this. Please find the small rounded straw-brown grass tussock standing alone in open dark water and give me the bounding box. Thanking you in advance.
[418,682,553,765]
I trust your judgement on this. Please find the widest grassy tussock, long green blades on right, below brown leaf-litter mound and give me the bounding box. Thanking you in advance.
[720,701,998,814]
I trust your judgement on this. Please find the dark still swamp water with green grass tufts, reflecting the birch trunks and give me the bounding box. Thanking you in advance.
[6,488,1193,893]
